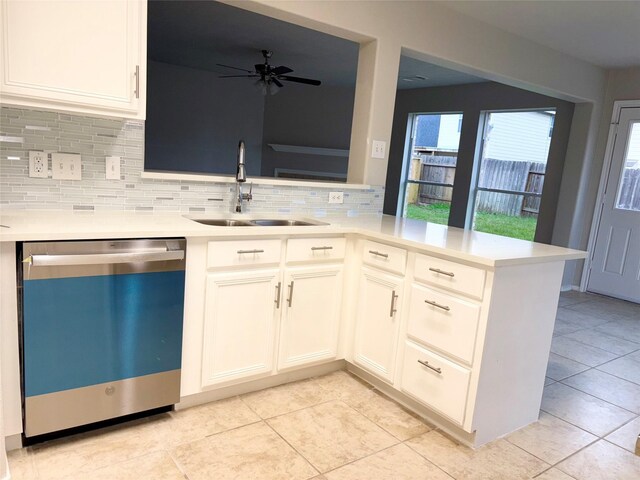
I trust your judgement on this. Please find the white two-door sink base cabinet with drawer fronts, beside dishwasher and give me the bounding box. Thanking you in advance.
[200,237,345,388]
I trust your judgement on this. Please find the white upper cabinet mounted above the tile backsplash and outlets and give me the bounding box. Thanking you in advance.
[0,0,147,119]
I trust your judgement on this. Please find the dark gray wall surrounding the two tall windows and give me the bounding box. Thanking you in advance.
[384,82,574,243]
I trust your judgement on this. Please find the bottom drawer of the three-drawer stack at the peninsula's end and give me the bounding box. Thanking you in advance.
[402,342,471,425]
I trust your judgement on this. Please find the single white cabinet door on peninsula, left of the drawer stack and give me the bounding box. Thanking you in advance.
[354,268,403,383]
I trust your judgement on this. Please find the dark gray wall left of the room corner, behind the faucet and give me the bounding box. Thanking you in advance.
[145,61,264,176]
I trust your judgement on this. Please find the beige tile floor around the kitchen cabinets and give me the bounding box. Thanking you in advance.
[9,293,640,480]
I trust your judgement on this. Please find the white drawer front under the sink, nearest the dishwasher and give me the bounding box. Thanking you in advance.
[207,239,281,268]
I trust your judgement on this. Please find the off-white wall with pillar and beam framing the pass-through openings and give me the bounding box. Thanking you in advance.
[229,0,606,286]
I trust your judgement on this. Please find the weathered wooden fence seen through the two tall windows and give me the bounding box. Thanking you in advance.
[416,155,544,216]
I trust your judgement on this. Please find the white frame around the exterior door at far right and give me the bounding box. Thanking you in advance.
[580,100,640,292]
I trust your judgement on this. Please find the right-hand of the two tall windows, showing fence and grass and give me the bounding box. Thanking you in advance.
[473,110,555,240]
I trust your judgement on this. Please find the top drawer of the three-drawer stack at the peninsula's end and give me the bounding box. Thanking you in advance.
[413,255,486,298]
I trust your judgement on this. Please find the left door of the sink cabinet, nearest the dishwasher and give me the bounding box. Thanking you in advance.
[202,270,279,387]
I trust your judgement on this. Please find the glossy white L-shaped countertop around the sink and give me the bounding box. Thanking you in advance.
[0,210,586,267]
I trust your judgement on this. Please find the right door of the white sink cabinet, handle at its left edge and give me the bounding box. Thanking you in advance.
[278,265,342,369]
